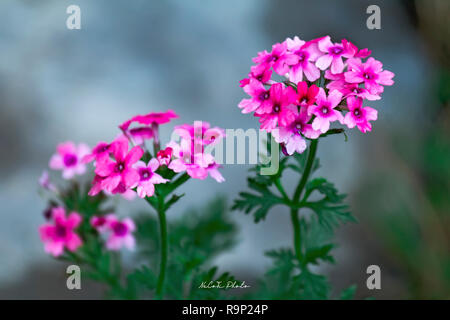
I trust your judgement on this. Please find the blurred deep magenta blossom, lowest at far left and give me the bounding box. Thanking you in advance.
[39,207,82,257]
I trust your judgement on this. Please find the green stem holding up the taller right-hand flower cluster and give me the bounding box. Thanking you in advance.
[291,139,319,265]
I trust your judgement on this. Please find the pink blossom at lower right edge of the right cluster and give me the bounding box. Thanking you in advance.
[344,97,378,133]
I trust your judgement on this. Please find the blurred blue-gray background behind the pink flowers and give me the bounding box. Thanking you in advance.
[0,0,446,298]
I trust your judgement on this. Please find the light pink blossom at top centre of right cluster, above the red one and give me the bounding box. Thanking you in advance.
[286,37,322,83]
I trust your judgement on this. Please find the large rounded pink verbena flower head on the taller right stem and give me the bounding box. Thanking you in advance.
[239,36,394,155]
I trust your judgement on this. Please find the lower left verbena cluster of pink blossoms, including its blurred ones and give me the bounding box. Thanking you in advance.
[39,110,225,256]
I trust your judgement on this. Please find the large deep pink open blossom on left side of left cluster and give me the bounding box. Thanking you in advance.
[91,141,144,193]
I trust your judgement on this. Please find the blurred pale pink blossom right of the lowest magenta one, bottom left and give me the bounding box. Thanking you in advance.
[91,214,136,251]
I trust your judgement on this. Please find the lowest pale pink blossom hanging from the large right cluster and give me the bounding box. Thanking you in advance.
[272,107,321,155]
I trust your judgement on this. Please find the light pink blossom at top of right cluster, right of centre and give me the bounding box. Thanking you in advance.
[316,36,352,73]
